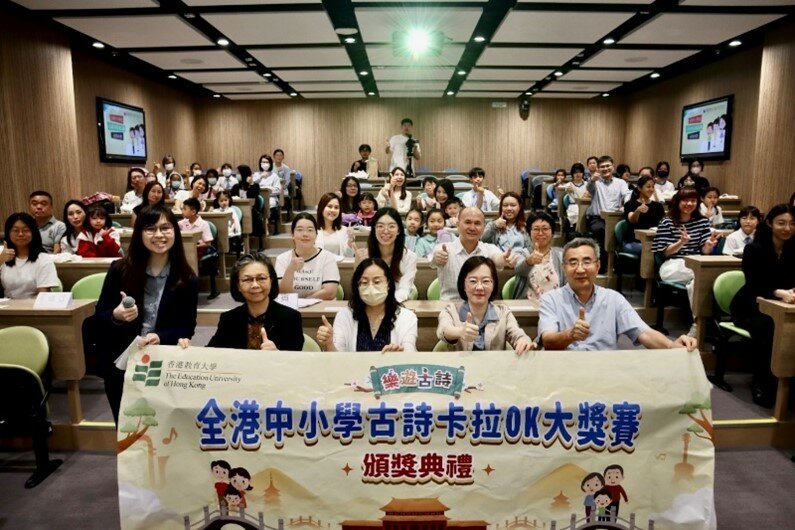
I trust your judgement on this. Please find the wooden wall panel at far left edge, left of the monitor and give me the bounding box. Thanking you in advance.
[0,11,79,214]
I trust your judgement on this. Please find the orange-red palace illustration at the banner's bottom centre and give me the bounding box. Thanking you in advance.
[341,497,488,530]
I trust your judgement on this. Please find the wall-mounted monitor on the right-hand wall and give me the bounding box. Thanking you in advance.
[679,95,734,160]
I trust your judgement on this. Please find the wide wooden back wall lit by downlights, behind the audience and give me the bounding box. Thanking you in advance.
[197,98,624,203]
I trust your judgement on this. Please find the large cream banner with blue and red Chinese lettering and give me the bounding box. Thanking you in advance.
[118,346,716,530]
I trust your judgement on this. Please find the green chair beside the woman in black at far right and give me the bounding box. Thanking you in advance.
[707,271,751,392]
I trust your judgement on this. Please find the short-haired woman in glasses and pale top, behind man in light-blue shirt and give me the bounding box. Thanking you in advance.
[513,212,566,302]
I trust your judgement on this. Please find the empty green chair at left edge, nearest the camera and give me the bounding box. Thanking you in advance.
[0,326,63,488]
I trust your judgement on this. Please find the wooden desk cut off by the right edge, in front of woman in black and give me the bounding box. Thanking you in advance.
[756,298,795,421]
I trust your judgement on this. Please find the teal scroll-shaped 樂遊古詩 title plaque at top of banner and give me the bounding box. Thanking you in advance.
[370,364,464,398]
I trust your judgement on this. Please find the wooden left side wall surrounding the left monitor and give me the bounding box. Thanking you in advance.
[73,50,201,197]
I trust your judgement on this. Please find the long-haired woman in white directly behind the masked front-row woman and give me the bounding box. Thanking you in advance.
[353,208,417,302]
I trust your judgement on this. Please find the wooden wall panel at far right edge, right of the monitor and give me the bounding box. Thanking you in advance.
[752,24,795,209]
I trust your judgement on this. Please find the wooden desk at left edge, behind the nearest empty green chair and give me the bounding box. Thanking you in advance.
[0,299,97,424]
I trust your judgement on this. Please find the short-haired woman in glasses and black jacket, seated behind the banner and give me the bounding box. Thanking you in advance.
[179,253,304,351]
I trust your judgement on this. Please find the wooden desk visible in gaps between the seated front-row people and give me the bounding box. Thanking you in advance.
[300,300,538,351]
